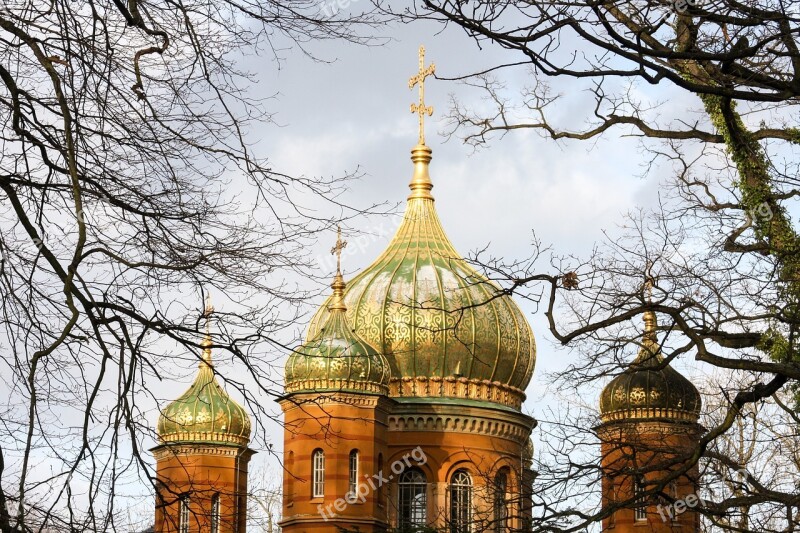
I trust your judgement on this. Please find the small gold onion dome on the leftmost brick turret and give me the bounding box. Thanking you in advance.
[158,335,250,446]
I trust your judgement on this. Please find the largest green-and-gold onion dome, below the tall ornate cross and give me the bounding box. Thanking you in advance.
[308,144,536,409]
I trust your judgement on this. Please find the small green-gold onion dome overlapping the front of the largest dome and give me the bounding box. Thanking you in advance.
[285,272,389,394]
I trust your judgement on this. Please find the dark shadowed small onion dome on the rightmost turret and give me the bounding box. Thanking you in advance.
[600,311,701,422]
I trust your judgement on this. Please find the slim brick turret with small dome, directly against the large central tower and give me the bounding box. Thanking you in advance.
[280,250,389,533]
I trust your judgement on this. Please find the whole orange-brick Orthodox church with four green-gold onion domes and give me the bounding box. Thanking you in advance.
[152,48,700,533]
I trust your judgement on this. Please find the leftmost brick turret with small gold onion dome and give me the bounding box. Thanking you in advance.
[152,300,254,533]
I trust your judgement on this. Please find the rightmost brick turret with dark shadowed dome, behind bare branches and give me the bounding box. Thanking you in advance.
[597,311,702,533]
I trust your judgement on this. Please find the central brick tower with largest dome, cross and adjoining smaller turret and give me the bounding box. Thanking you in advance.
[281,48,536,533]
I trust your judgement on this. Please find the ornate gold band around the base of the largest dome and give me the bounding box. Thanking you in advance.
[389,376,525,410]
